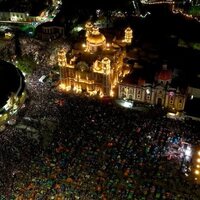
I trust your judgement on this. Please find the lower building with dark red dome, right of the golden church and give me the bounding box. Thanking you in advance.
[118,65,186,112]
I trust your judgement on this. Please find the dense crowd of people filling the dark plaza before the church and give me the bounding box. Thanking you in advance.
[0,59,200,200]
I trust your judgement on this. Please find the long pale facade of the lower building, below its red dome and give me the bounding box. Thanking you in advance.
[118,84,186,112]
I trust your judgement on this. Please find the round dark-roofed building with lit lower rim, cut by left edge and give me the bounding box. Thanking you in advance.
[0,61,26,130]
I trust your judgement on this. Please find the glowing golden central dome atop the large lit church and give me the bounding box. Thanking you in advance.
[87,28,106,46]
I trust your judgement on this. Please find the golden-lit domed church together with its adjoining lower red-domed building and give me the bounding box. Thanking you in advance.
[58,22,186,112]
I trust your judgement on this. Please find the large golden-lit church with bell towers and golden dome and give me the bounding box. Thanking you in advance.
[58,22,129,96]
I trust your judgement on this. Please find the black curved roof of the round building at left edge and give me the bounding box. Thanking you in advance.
[0,60,25,108]
